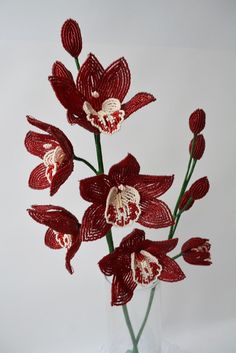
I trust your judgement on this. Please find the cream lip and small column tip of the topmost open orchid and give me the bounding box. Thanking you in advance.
[83,97,125,134]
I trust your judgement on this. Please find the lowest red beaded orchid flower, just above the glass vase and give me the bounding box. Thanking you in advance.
[99,229,185,305]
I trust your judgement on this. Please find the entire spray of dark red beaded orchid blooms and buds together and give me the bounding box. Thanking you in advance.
[25,19,211,305]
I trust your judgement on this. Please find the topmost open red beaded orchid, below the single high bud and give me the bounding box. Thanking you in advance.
[49,54,155,134]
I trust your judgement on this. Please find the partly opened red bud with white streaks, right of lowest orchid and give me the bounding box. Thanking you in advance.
[181,238,212,266]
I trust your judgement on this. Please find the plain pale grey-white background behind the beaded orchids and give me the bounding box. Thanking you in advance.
[0,0,236,353]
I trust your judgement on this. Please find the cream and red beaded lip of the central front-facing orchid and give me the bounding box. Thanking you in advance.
[105,184,141,227]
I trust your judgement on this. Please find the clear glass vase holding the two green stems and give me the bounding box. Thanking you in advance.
[105,282,162,353]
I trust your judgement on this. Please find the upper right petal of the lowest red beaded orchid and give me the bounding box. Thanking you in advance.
[143,238,178,258]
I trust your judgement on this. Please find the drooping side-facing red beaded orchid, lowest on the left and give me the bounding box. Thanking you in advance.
[28,205,81,274]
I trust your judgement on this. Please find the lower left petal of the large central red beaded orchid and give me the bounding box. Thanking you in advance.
[80,204,111,241]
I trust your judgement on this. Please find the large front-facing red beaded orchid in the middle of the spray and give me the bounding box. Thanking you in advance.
[80,154,174,241]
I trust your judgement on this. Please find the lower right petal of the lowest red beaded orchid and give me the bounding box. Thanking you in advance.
[158,256,185,282]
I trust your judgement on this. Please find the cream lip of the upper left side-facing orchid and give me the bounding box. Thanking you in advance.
[43,146,65,184]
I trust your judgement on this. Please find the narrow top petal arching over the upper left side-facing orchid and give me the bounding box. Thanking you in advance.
[27,116,74,158]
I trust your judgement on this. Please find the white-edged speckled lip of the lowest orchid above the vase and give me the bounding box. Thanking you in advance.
[131,250,162,286]
